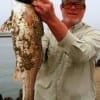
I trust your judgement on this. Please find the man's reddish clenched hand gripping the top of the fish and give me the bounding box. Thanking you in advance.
[32,0,56,24]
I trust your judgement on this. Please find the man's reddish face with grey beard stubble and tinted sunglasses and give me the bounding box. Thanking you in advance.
[61,0,85,25]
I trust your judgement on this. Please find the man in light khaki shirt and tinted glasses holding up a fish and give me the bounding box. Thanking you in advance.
[33,0,100,100]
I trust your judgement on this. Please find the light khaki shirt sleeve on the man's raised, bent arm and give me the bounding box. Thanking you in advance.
[59,30,100,63]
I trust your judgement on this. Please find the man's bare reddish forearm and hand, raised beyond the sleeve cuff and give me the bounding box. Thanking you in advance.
[32,0,68,41]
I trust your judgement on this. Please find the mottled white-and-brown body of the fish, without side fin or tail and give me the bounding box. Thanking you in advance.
[12,1,43,70]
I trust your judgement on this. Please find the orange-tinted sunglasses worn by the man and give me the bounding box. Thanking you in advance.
[62,2,85,9]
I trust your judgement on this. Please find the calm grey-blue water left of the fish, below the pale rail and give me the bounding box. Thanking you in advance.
[0,37,21,100]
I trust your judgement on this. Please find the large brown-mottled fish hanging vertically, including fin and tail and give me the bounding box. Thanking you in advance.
[0,0,44,100]
